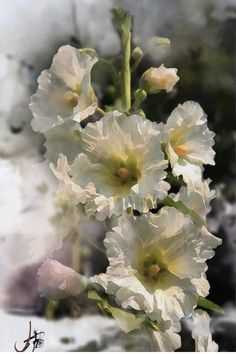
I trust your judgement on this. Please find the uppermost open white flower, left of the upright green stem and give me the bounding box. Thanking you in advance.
[30,45,97,133]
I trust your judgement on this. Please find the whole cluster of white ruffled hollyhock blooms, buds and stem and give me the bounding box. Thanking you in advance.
[30,10,221,351]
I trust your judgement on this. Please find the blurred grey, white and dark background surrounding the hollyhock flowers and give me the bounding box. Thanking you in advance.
[0,0,236,351]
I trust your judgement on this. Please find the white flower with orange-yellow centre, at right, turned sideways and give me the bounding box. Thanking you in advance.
[164,101,215,184]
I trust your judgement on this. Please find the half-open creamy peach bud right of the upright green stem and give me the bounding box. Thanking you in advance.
[141,64,179,94]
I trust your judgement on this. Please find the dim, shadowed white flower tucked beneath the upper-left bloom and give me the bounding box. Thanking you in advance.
[44,120,82,163]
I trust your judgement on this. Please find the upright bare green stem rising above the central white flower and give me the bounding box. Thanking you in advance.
[121,30,131,112]
